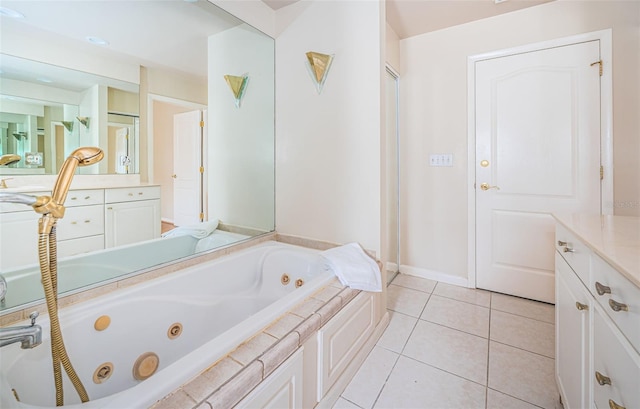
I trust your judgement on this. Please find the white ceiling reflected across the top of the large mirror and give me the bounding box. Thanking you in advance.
[0,0,241,78]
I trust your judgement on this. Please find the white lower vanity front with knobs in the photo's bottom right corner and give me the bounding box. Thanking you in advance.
[591,306,640,409]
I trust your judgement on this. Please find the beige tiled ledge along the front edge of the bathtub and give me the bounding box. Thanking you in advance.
[152,279,360,409]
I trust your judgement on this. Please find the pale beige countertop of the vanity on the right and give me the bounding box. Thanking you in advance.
[553,213,640,287]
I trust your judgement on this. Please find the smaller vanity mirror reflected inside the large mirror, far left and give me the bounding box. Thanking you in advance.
[0,54,140,175]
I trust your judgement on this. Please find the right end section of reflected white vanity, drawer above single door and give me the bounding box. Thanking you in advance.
[104,186,161,248]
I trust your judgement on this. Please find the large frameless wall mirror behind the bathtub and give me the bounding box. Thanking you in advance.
[0,0,275,315]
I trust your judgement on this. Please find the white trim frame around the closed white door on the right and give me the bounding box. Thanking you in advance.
[467,29,613,288]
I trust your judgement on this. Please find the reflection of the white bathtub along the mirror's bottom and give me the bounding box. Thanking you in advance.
[1,230,249,311]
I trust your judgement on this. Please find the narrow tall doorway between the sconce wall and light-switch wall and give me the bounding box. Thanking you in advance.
[385,66,400,284]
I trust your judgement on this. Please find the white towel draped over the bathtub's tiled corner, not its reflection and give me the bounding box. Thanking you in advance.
[320,243,382,292]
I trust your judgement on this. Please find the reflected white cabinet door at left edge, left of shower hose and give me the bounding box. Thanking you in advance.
[0,210,40,272]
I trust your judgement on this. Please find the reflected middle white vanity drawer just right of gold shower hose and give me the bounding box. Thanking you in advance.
[57,205,104,240]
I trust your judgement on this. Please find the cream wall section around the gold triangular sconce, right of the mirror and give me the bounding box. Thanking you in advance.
[276,1,384,254]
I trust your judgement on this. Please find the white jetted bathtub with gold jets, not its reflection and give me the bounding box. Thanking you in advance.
[0,241,333,409]
